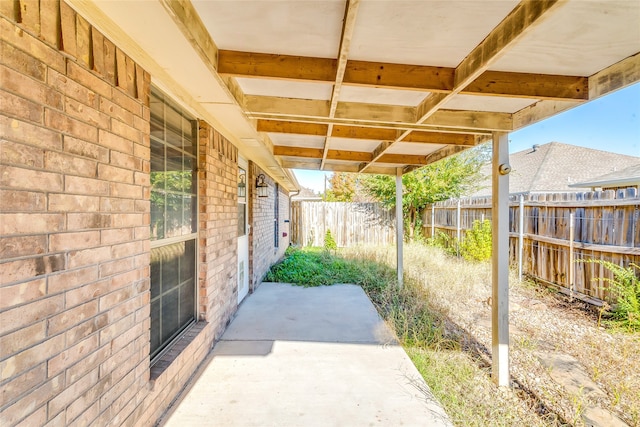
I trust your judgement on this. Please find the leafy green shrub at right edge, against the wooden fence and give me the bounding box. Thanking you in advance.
[585,260,640,332]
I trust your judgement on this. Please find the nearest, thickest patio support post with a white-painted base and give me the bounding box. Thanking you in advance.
[491,132,511,387]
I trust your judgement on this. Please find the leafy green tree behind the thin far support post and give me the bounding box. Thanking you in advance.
[361,146,488,240]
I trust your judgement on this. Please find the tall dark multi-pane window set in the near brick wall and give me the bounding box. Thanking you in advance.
[151,88,198,363]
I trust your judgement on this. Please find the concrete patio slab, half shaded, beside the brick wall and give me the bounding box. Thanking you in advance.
[165,283,451,427]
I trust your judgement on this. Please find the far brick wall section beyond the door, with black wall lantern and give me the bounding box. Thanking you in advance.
[249,162,290,290]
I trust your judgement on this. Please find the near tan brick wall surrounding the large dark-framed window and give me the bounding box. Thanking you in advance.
[0,4,237,426]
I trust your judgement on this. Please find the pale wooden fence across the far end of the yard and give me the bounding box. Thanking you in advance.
[291,201,396,247]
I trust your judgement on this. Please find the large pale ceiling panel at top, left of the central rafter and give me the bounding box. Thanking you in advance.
[193,0,345,58]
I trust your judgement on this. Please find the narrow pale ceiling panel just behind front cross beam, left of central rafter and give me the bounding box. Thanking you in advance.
[236,78,333,101]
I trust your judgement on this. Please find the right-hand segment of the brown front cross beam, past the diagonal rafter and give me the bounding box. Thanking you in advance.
[460,71,589,101]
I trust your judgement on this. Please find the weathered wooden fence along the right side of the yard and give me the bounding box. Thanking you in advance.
[423,188,640,302]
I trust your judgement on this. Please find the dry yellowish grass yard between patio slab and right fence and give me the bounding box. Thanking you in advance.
[340,245,640,426]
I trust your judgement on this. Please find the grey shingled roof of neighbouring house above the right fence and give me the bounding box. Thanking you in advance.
[472,142,640,196]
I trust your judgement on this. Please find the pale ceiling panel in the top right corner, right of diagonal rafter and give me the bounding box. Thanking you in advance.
[491,0,640,76]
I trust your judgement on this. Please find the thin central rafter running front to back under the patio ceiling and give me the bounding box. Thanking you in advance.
[320,0,360,169]
